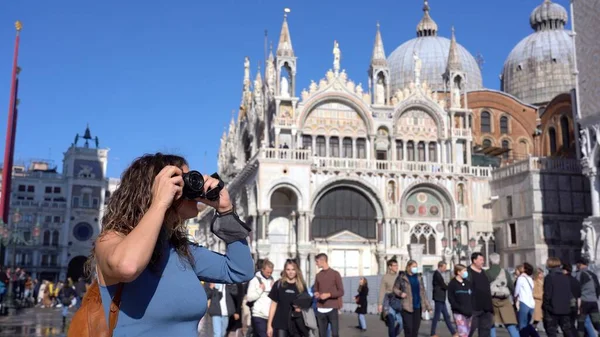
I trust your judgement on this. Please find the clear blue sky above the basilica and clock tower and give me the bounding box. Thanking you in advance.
[0,0,570,177]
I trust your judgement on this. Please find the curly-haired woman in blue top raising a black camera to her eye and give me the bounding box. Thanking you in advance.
[89,153,254,337]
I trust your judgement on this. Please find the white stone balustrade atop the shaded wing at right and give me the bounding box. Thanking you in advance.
[492,157,581,180]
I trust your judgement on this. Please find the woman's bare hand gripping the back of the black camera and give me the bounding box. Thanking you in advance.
[152,165,183,211]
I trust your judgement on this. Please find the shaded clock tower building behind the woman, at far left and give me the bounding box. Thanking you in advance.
[2,128,118,281]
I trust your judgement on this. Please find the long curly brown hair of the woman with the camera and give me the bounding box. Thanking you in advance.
[86,152,194,275]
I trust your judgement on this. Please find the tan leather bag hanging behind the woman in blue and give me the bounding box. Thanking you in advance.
[67,280,123,337]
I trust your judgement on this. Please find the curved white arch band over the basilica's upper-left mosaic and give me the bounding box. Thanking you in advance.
[298,92,373,134]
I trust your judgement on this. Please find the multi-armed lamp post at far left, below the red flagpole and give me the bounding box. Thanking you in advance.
[0,209,40,316]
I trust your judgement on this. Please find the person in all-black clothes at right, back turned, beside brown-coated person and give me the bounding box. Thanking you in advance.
[542,257,575,337]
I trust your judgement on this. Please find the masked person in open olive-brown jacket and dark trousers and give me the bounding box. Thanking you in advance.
[394,260,432,337]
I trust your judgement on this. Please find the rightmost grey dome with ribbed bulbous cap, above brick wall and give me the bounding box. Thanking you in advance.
[502,0,575,104]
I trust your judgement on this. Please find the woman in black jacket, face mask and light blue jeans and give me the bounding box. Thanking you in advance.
[448,264,473,337]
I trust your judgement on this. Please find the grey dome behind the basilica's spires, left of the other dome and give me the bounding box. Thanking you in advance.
[387,1,483,92]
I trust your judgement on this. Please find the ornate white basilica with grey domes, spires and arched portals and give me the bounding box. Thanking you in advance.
[188,0,590,280]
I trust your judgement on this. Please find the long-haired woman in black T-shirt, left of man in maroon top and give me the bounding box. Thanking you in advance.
[267,259,308,337]
